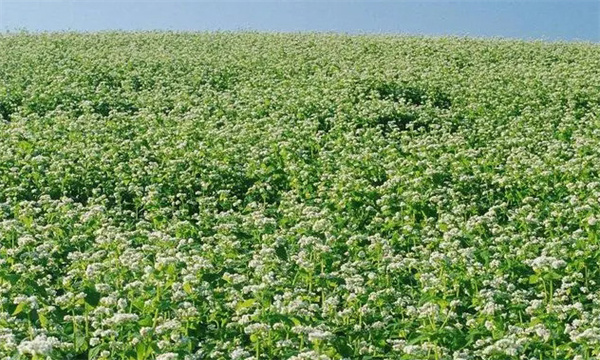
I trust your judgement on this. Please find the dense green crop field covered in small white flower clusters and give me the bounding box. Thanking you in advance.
[0,32,600,360]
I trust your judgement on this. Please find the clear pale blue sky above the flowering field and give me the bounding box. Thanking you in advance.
[0,0,600,42]
